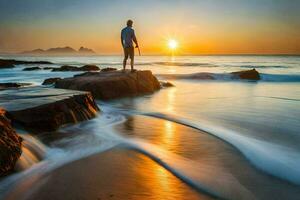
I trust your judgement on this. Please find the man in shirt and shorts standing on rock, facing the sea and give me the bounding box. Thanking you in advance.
[121,20,139,71]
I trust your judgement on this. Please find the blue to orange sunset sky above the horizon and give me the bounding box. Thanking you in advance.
[0,0,300,55]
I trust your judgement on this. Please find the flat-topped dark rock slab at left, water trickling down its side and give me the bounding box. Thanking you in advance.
[0,87,99,133]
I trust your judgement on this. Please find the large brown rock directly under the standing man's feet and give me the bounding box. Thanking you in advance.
[55,70,160,100]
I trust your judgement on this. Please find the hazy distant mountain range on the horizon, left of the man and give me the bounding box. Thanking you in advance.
[21,46,96,55]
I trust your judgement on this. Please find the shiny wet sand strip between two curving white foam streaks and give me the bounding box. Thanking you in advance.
[116,115,300,199]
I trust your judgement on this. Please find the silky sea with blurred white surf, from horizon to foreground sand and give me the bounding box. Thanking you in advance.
[0,56,300,199]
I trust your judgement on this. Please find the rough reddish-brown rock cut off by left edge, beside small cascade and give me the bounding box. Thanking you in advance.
[0,108,22,176]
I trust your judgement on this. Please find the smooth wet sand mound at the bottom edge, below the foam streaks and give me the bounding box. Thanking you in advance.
[7,148,211,200]
